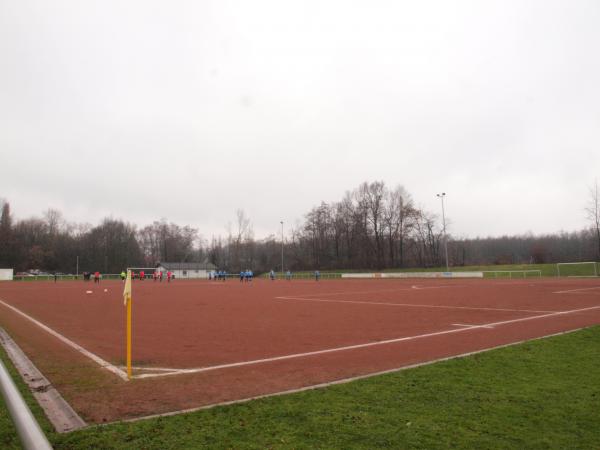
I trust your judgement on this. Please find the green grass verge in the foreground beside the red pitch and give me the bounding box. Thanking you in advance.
[0,327,600,449]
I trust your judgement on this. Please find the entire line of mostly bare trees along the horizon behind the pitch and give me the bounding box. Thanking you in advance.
[0,181,600,273]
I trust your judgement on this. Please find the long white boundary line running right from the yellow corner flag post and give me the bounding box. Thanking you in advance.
[134,306,600,378]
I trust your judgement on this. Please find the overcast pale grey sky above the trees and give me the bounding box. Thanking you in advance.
[0,0,600,243]
